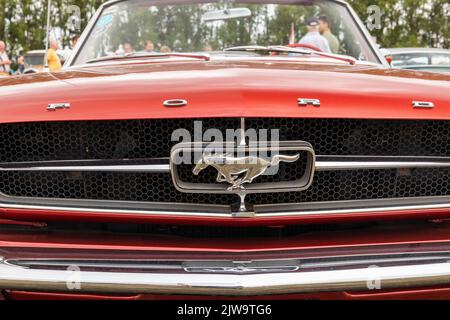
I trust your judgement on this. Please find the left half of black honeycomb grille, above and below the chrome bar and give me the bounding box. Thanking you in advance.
[0,119,240,205]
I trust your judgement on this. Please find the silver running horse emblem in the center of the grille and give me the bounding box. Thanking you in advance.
[193,154,300,191]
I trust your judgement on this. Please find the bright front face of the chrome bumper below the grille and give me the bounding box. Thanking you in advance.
[0,261,450,296]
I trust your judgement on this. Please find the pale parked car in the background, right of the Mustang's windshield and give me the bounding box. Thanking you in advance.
[388,48,450,73]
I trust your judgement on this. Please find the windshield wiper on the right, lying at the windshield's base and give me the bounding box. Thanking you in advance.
[224,46,356,65]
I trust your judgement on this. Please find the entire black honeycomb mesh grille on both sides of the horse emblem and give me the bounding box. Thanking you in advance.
[0,119,450,208]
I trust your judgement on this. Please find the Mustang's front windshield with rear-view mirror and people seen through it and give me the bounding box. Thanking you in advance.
[74,0,379,64]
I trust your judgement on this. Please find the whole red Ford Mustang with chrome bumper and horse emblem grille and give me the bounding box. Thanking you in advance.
[0,0,450,299]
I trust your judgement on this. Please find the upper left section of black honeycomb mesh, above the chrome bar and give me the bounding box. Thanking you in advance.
[0,119,240,162]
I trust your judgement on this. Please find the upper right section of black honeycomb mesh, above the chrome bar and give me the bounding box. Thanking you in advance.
[246,118,450,156]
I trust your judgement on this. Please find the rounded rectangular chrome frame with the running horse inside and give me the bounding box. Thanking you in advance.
[170,141,315,197]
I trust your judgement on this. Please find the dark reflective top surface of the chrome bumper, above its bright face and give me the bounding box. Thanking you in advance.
[9,251,450,273]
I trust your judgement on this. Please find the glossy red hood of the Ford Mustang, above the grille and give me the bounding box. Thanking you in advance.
[0,58,450,122]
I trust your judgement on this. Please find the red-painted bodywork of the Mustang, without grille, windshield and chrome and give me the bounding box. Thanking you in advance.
[0,0,450,300]
